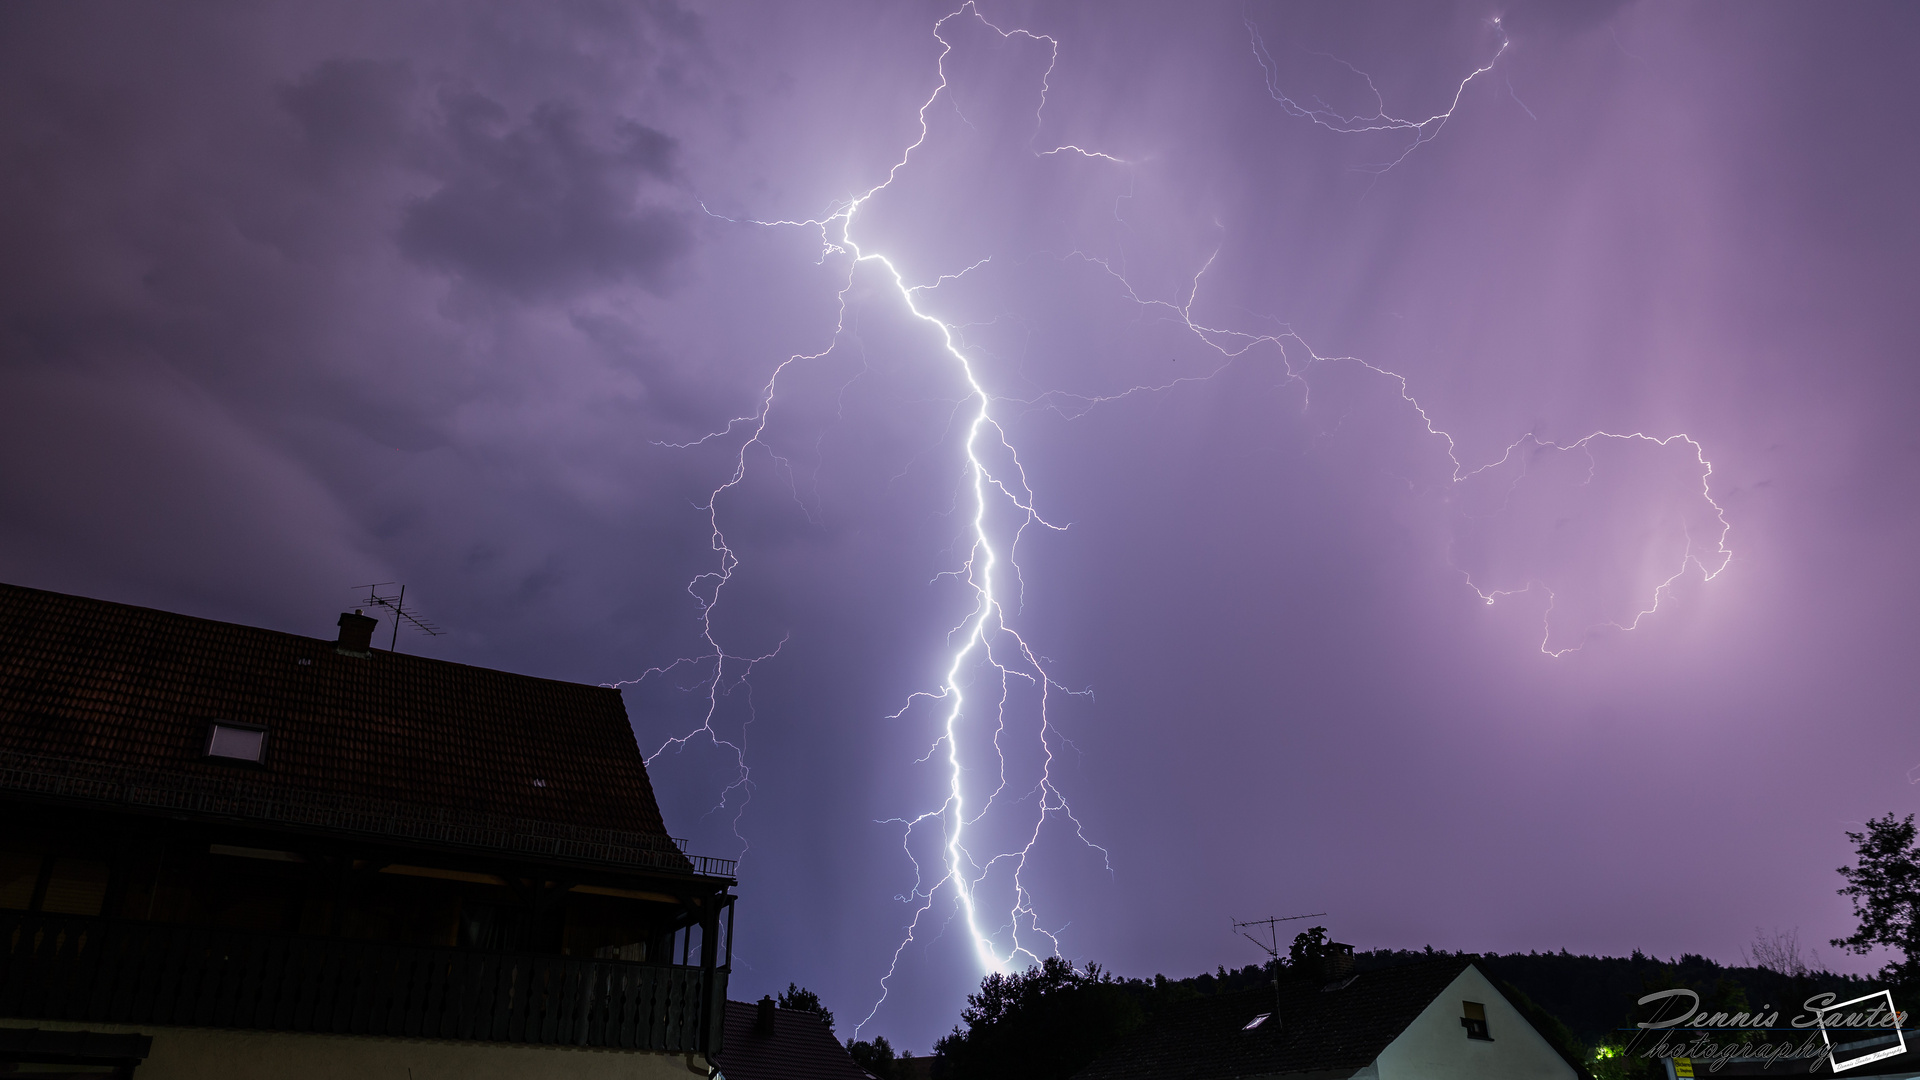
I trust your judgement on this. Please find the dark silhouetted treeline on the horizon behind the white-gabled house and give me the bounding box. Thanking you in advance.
[849,813,1920,1080]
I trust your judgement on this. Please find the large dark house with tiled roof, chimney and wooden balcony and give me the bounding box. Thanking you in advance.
[0,586,733,1080]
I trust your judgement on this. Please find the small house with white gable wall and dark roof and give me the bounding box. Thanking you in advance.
[1075,957,1576,1080]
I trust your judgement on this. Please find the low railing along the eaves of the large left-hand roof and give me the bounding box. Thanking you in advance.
[0,753,737,878]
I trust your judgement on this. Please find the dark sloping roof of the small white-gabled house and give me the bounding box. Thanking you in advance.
[1073,957,1469,1080]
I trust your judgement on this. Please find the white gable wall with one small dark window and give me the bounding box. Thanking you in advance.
[1369,967,1574,1080]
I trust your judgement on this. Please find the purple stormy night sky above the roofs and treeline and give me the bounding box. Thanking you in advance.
[0,2,1920,1051]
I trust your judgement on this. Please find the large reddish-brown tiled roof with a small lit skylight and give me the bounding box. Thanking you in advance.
[0,584,666,840]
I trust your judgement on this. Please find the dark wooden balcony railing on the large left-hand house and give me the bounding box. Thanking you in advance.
[0,911,726,1055]
